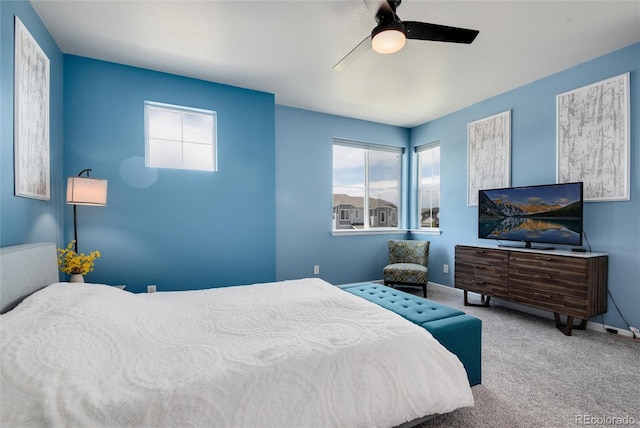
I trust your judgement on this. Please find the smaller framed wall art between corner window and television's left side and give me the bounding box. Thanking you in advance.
[467,110,511,206]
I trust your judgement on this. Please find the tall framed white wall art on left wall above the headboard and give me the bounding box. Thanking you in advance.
[14,16,51,201]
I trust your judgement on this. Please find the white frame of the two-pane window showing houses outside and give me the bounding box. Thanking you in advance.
[331,138,407,235]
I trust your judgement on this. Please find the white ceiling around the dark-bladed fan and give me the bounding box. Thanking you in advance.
[31,0,640,127]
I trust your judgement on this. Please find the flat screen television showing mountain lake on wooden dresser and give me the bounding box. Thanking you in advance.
[478,182,584,249]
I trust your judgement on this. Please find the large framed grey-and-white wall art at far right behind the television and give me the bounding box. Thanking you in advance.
[556,73,631,201]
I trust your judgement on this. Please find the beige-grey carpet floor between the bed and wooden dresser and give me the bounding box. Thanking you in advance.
[403,285,640,428]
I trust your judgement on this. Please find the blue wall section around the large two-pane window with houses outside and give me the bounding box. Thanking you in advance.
[276,106,409,284]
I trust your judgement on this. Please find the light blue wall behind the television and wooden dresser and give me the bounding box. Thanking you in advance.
[411,43,640,329]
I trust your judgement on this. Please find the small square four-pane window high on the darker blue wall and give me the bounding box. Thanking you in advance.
[144,102,218,171]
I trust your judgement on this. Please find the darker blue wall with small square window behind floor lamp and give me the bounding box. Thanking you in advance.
[64,55,276,291]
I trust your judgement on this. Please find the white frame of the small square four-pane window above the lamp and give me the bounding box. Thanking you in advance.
[144,101,218,172]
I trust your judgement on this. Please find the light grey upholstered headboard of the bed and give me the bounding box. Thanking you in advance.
[0,242,59,313]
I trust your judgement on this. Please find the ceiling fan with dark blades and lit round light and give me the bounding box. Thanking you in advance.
[333,0,479,70]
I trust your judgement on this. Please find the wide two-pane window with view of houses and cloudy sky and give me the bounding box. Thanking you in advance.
[333,139,403,230]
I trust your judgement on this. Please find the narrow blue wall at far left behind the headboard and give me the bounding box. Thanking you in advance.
[0,1,65,251]
